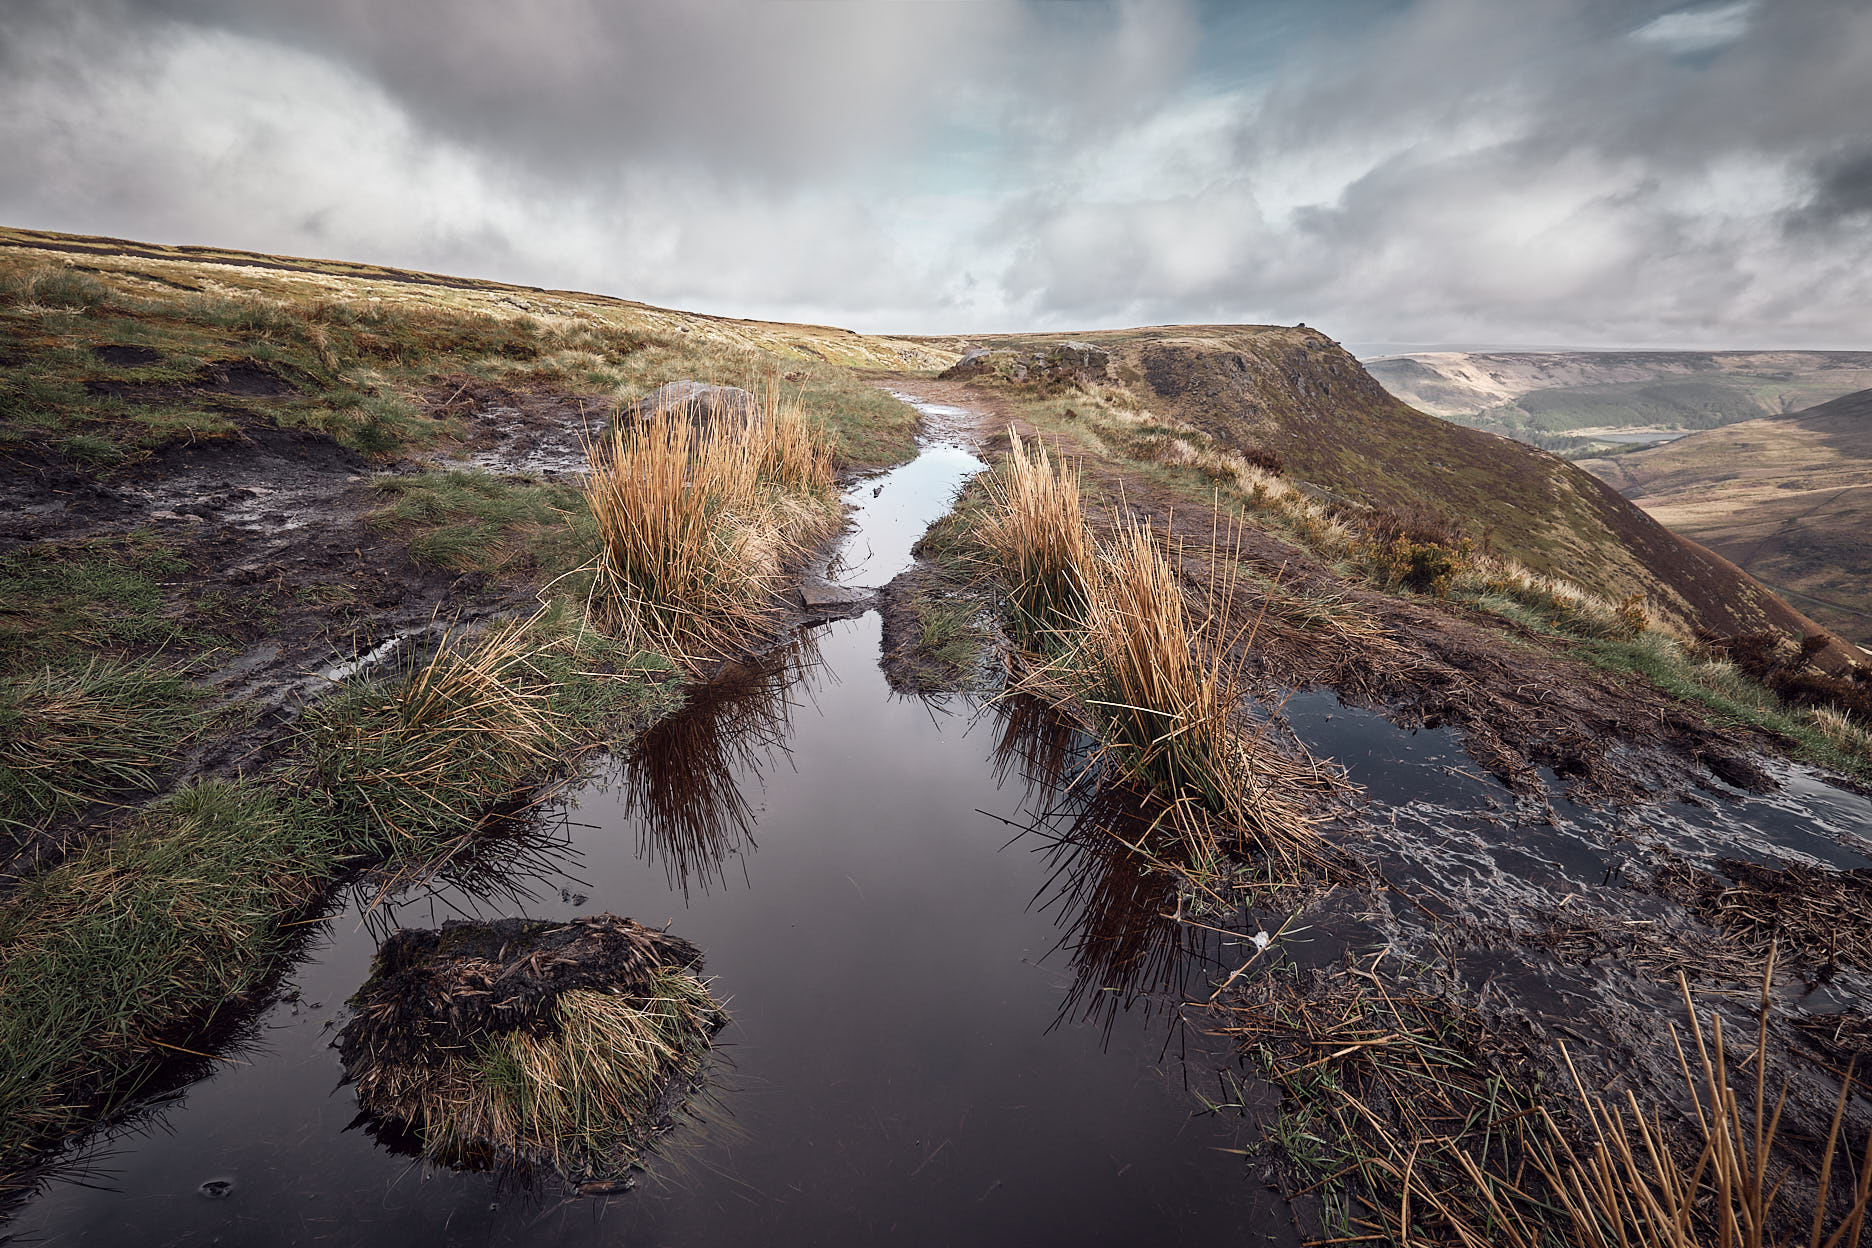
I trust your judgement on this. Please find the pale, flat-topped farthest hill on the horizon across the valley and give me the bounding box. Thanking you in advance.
[1365,352,1872,451]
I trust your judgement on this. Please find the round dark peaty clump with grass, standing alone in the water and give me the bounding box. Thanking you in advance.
[339,915,726,1184]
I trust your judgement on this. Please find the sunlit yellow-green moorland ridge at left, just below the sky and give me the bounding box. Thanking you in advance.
[0,230,945,475]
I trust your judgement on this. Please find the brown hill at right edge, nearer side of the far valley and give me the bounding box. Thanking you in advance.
[1580,389,1872,646]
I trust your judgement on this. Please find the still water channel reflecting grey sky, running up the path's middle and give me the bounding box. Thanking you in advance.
[9,412,1290,1246]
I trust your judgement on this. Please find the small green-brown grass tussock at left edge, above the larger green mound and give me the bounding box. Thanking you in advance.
[0,659,200,836]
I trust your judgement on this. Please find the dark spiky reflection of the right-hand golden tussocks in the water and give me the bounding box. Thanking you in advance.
[994,694,1213,1033]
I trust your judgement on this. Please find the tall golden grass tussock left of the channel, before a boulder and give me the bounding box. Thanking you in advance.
[584,391,839,666]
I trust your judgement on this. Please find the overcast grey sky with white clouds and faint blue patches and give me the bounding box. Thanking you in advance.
[0,0,1872,348]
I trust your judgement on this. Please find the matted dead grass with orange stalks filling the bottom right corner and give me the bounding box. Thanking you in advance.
[1215,949,1872,1248]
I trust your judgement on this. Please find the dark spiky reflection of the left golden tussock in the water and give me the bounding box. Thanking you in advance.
[622,631,824,898]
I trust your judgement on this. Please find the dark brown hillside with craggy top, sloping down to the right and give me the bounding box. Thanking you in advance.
[909,326,1842,658]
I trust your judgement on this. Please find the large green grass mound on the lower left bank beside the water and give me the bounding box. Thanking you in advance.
[0,784,341,1190]
